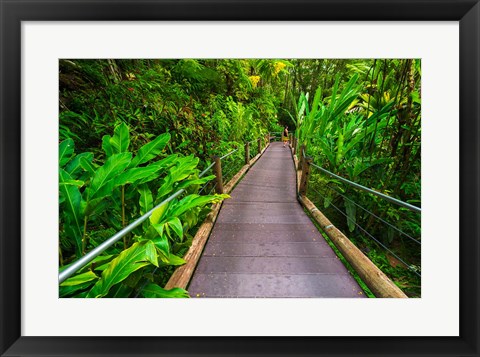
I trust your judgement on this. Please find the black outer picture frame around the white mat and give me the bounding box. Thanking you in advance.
[0,0,480,356]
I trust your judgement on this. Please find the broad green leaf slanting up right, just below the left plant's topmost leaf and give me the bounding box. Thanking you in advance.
[88,152,132,199]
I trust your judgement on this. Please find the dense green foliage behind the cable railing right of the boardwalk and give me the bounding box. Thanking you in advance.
[293,60,421,296]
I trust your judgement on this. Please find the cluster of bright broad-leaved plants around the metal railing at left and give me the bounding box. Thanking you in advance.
[59,123,228,298]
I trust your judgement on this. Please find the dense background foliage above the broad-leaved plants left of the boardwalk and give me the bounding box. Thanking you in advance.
[60,59,284,165]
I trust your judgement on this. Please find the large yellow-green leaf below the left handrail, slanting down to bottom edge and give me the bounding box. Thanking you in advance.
[87,241,155,298]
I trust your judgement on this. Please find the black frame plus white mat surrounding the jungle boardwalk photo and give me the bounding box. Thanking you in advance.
[0,0,480,356]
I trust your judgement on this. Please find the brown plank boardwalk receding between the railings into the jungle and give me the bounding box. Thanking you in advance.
[188,143,365,298]
